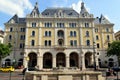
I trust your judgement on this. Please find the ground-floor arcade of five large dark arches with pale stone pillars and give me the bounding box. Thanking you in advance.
[24,51,99,69]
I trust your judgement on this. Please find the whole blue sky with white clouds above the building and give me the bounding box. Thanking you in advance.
[0,0,120,32]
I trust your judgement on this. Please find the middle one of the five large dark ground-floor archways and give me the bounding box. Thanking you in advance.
[56,53,66,67]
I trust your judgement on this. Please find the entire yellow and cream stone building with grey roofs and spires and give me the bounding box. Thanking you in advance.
[3,2,116,69]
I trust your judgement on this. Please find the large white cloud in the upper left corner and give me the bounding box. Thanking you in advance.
[0,0,33,17]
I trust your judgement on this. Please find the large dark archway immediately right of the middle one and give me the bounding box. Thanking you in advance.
[70,53,78,67]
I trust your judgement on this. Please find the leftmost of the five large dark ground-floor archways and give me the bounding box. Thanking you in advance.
[28,53,37,67]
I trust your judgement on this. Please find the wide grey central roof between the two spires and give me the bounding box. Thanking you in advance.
[42,8,79,17]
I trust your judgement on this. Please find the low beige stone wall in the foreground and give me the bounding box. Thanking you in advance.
[25,70,105,80]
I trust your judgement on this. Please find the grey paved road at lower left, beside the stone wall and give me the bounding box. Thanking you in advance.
[0,72,23,80]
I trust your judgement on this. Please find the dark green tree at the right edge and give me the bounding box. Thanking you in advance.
[107,41,120,65]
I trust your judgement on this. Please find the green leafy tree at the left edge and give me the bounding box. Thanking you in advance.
[0,43,12,65]
